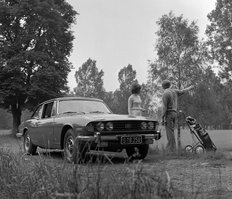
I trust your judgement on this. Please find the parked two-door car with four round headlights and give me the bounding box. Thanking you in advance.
[17,97,161,163]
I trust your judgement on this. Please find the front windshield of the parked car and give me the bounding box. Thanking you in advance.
[58,100,111,114]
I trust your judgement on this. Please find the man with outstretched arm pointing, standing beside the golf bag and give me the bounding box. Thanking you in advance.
[162,80,194,152]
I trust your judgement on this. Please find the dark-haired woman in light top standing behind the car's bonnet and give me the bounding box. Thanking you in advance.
[128,83,144,116]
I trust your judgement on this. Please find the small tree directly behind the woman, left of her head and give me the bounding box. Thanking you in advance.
[114,64,138,114]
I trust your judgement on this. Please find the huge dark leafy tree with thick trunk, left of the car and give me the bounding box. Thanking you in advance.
[0,0,77,133]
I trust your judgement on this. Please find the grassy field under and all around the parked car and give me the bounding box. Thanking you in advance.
[0,130,232,199]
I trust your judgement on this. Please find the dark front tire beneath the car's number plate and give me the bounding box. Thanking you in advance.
[126,144,149,159]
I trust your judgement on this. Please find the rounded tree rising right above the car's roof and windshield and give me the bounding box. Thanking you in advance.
[74,58,105,99]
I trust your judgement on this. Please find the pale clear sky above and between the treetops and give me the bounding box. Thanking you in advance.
[67,0,216,91]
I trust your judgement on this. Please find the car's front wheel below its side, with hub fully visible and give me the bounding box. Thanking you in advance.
[63,129,87,164]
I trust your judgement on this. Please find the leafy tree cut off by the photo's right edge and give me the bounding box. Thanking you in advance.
[206,0,232,126]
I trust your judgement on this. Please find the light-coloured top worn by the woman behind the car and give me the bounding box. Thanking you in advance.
[128,94,143,116]
